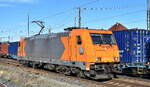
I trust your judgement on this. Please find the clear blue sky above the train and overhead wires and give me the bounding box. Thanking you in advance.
[0,0,146,41]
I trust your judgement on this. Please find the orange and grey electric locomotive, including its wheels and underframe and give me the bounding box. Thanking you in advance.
[18,28,120,79]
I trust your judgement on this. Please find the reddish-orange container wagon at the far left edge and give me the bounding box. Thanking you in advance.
[0,42,8,57]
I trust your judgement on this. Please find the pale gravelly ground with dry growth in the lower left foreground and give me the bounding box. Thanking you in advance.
[0,64,84,87]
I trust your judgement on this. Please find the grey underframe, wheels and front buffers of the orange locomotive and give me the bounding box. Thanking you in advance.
[18,57,117,79]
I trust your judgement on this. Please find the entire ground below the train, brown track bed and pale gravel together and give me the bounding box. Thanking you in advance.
[0,58,150,87]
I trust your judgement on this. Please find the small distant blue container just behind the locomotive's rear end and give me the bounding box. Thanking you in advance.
[8,42,19,56]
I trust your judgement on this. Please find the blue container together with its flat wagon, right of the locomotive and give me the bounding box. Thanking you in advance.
[113,29,150,75]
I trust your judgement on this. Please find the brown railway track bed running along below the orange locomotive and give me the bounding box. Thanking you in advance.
[0,59,150,87]
